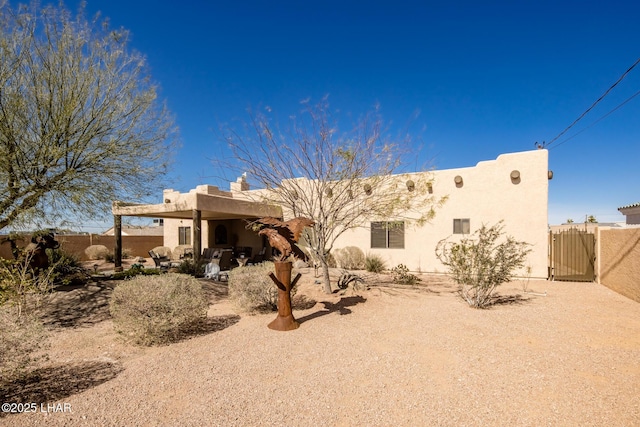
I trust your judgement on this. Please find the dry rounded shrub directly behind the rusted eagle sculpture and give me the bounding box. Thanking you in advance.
[229,261,297,313]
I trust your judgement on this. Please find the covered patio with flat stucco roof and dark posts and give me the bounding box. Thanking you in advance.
[112,184,283,270]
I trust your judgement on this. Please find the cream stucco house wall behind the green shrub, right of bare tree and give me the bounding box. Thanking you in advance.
[335,150,549,278]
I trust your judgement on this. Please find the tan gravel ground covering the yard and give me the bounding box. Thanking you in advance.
[0,272,640,426]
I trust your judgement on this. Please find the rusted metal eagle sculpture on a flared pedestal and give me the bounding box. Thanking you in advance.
[253,217,315,331]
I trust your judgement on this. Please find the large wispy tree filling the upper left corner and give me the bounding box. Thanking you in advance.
[0,0,177,229]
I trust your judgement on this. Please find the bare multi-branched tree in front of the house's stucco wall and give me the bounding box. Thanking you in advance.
[226,98,443,293]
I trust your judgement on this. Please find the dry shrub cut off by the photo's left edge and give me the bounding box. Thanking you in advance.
[0,304,48,383]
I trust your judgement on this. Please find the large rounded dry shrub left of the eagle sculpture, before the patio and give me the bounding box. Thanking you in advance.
[109,273,208,346]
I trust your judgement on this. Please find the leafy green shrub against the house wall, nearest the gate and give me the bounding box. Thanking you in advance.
[436,221,531,308]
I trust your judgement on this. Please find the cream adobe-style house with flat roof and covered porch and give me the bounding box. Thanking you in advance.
[113,150,551,278]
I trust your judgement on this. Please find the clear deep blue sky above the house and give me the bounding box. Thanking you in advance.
[66,0,640,229]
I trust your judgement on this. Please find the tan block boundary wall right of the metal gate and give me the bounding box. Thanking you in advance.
[597,228,640,302]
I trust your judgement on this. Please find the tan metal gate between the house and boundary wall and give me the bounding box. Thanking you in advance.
[549,228,596,282]
